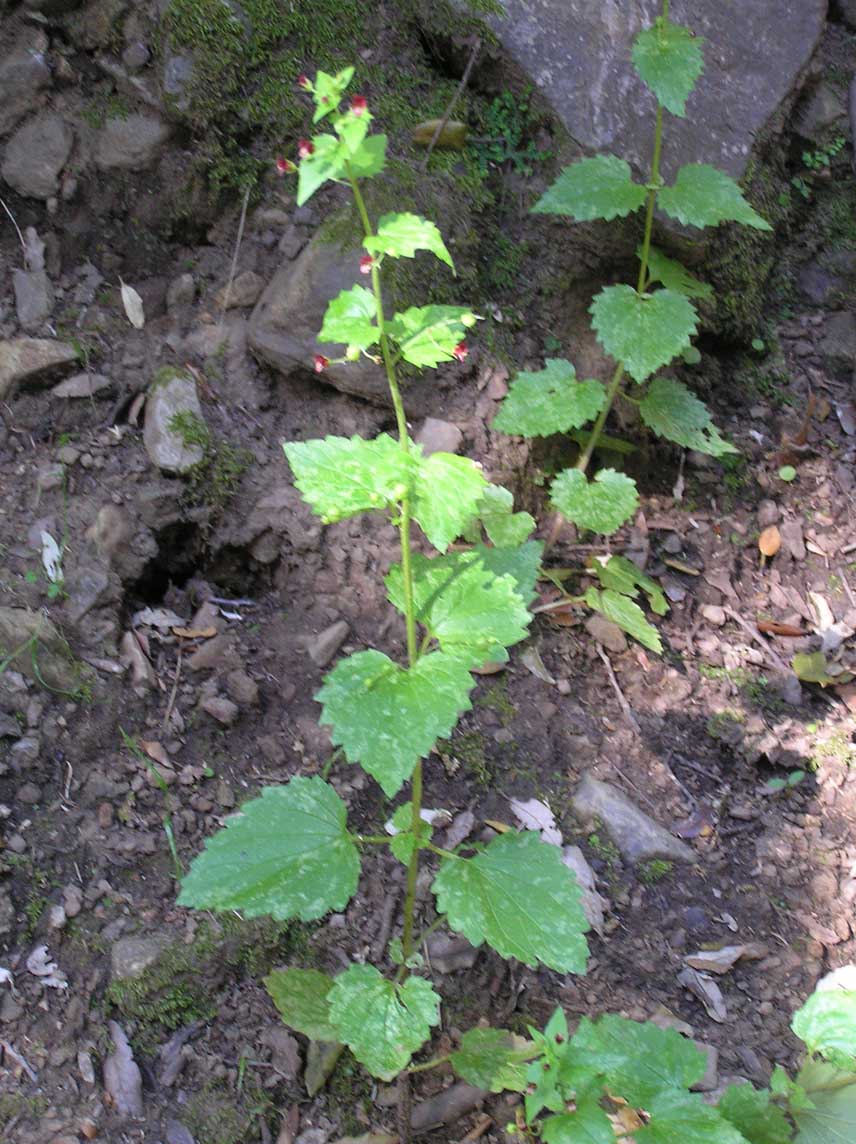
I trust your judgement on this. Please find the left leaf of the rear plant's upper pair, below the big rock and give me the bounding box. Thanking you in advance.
[532,154,648,222]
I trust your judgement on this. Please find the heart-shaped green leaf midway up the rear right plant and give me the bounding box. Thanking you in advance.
[591,285,698,382]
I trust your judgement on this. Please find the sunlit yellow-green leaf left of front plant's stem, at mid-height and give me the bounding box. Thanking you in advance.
[283,434,415,524]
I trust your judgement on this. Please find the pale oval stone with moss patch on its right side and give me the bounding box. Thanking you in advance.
[143,373,206,472]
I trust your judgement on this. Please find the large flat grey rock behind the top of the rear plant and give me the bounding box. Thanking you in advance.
[457,0,827,177]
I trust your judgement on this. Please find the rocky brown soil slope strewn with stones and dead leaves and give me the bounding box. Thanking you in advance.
[0,2,856,1144]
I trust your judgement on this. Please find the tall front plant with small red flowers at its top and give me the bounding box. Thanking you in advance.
[179,67,588,1131]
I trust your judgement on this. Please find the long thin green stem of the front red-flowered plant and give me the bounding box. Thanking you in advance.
[348,170,422,962]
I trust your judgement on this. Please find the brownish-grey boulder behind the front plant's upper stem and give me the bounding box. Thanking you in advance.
[248,236,391,405]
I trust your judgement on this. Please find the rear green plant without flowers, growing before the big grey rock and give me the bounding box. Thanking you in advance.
[493,0,770,651]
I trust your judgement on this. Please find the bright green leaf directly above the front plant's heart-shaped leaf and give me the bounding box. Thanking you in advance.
[386,553,530,668]
